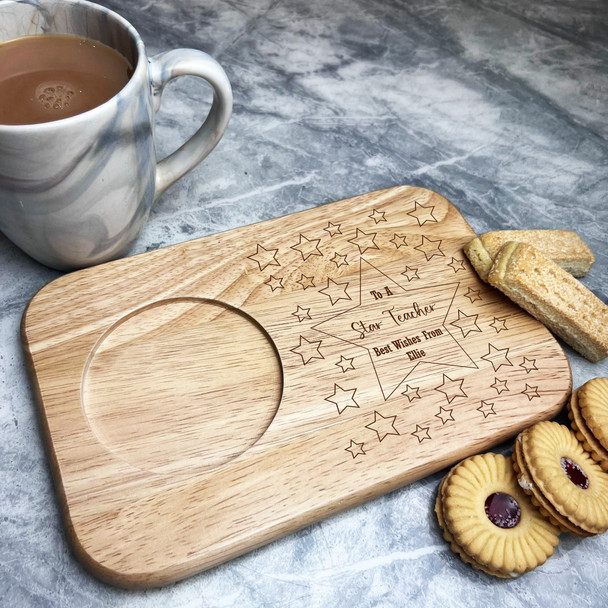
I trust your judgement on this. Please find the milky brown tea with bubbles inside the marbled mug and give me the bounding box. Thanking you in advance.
[0,34,133,125]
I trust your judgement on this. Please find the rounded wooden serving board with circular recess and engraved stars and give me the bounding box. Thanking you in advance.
[22,187,571,587]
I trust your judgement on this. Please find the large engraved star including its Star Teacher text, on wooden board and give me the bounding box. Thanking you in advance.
[313,258,477,400]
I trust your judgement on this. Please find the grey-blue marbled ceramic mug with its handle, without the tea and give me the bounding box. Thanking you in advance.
[0,0,232,270]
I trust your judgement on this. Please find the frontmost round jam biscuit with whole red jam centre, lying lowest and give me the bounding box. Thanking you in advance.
[442,454,559,576]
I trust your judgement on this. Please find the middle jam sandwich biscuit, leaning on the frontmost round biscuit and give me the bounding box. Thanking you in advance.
[521,421,608,534]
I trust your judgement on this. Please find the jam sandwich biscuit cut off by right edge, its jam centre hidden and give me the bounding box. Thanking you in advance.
[568,378,608,471]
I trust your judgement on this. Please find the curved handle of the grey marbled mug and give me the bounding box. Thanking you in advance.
[148,49,232,200]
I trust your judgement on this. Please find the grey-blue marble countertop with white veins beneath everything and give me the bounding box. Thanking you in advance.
[0,0,608,608]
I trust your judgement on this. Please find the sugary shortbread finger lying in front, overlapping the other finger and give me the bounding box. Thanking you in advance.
[488,242,608,362]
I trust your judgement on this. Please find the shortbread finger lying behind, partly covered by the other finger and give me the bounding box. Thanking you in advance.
[464,230,595,281]
